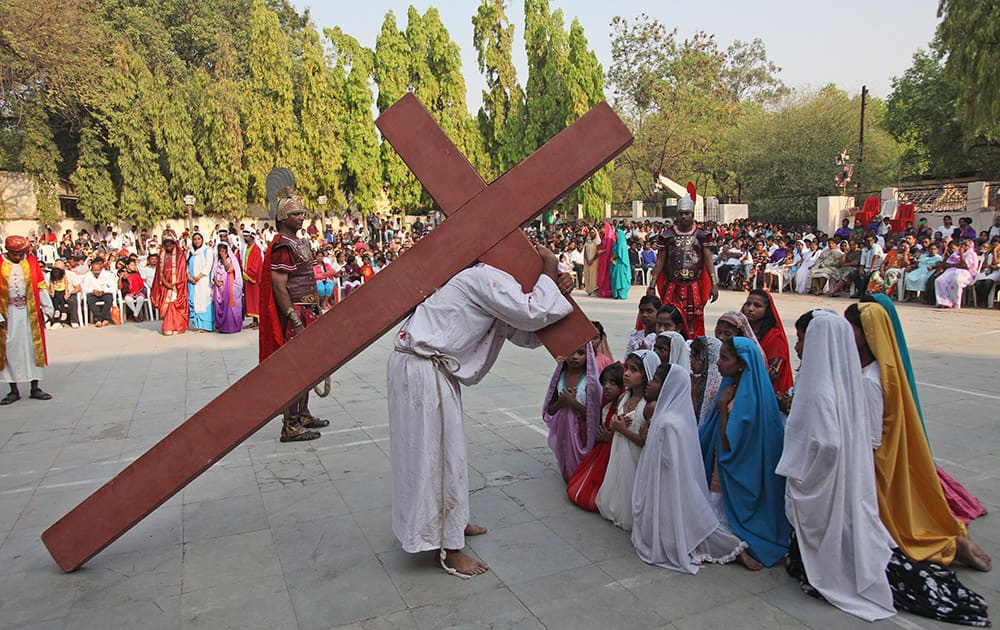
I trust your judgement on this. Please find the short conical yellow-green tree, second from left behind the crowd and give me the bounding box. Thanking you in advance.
[70,120,118,224]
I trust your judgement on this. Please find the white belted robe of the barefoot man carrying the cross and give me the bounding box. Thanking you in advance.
[387,264,572,553]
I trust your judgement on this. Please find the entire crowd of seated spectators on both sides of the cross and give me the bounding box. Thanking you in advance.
[3,209,1000,336]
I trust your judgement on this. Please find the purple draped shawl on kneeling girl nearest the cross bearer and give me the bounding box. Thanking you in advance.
[542,342,603,481]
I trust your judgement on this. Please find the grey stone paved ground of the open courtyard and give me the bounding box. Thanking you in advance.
[0,289,1000,630]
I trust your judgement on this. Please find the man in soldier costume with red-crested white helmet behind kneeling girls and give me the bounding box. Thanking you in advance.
[646,182,719,337]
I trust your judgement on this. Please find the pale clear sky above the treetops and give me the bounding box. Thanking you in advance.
[292,0,938,111]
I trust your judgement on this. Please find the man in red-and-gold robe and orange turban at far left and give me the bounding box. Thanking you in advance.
[0,236,52,405]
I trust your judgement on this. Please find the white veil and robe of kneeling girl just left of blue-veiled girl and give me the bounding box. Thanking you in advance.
[632,368,747,574]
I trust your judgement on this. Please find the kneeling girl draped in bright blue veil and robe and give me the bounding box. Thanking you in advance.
[698,337,791,570]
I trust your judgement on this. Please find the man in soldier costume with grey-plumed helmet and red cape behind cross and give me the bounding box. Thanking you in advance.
[259,193,330,442]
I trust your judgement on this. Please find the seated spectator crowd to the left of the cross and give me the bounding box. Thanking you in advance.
[5,214,431,328]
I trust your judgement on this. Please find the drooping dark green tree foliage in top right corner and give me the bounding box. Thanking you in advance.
[937,0,1000,141]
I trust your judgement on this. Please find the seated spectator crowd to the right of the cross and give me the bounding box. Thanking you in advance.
[542,214,1000,308]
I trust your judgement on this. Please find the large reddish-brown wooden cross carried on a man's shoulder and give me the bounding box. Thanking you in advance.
[42,95,632,571]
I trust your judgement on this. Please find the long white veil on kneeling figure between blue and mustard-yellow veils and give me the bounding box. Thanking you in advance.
[775,311,895,621]
